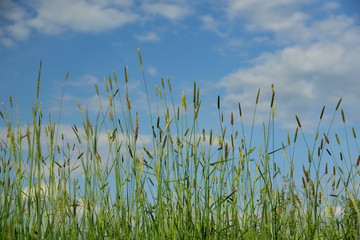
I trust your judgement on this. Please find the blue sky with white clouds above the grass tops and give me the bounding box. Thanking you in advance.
[0,0,360,189]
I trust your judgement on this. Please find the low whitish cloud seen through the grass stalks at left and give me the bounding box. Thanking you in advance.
[0,120,152,178]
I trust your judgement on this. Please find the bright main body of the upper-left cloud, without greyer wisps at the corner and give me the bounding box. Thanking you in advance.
[29,0,138,34]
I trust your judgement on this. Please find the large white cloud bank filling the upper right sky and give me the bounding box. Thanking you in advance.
[217,1,360,131]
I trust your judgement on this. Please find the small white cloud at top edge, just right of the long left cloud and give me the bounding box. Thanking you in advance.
[141,3,190,20]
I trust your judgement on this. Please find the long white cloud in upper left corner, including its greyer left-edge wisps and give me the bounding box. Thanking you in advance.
[0,0,139,46]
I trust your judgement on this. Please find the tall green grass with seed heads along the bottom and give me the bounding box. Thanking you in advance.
[0,52,360,239]
